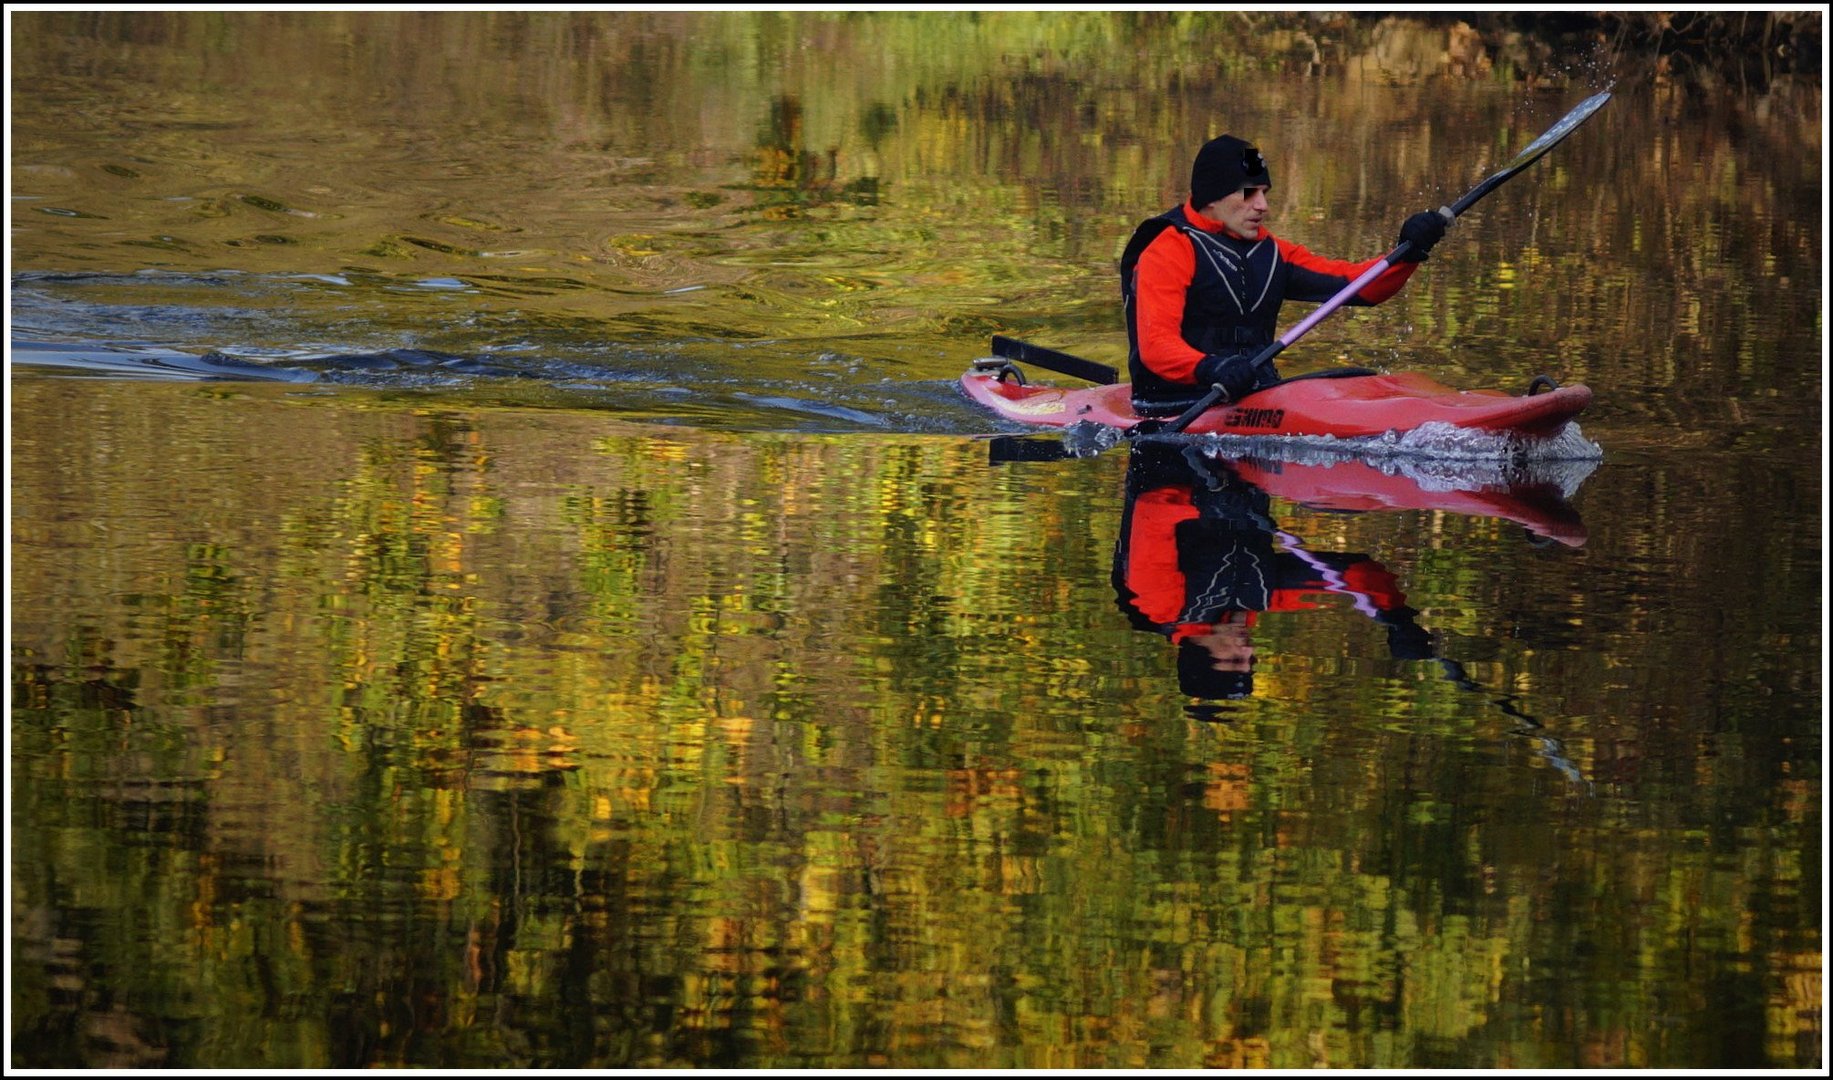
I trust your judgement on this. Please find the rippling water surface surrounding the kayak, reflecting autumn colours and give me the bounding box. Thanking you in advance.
[9,13,1824,1069]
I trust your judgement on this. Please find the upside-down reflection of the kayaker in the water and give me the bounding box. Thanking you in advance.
[1114,442,1432,699]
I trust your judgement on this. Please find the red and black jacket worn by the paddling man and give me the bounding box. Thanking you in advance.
[1120,202,1419,402]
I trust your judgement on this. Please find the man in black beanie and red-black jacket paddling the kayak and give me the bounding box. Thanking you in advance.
[1120,136,1444,416]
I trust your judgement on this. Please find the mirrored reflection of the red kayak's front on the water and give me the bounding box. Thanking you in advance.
[1228,458,1587,548]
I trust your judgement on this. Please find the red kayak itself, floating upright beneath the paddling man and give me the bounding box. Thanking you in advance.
[960,367,1591,438]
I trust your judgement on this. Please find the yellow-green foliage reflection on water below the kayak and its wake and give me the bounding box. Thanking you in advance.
[11,381,1818,1067]
